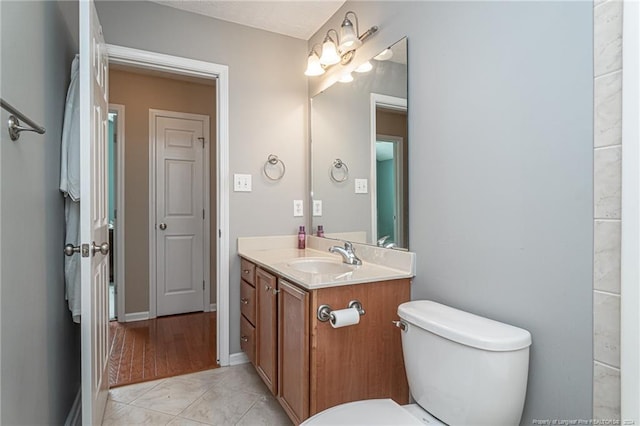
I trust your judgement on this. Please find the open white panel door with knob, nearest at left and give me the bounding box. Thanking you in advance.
[79,0,109,425]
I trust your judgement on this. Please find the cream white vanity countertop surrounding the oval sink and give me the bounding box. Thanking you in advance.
[238,236,415,290]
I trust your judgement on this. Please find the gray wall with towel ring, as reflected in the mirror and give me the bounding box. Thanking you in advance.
[311,61,407,243]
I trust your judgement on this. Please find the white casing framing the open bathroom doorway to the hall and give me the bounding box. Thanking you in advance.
[107,45,229,366]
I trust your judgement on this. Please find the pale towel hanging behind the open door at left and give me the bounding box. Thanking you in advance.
[60,55,81,322]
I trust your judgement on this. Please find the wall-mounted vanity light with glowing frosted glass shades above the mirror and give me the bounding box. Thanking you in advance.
[305,11,378,76]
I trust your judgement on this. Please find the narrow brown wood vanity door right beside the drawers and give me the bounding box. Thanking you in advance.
[256,268,278,395]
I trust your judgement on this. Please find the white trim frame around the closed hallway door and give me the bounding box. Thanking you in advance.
[149,108,211,318]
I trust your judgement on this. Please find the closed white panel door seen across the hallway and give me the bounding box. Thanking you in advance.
[150,110,209,316]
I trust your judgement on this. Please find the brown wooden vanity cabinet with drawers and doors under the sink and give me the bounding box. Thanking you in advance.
[240,257,410,424]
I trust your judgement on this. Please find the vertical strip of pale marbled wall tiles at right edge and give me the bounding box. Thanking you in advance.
[593,0,623,419]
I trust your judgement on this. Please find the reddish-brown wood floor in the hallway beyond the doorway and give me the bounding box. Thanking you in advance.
[109,312,218,387]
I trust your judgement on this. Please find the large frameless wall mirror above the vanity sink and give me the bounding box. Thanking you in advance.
[311,38,409,249]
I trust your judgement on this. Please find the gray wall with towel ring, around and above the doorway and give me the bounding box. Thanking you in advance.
[97,1,308,353]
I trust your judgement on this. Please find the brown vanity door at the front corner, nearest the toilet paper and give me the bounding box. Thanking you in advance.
[278,280,309,424]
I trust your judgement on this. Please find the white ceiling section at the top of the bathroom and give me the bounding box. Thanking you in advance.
[151,0,345,40]
